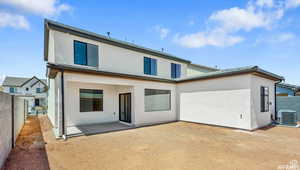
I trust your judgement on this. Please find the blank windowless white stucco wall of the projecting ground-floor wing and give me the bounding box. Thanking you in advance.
[177,75,251,129]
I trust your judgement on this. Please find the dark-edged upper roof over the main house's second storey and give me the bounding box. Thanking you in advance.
[44,19,191,63]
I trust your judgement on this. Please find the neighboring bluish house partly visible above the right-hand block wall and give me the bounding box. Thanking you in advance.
[276,83,300,96]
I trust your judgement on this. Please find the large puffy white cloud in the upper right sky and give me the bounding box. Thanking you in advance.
[174,0,300,48]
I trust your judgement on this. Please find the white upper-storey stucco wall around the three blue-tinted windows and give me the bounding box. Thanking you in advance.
[48,30,187,79]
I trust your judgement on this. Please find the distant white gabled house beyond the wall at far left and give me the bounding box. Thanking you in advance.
[2,76,48,112]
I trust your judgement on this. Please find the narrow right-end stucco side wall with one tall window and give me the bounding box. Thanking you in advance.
[251,75,275,129]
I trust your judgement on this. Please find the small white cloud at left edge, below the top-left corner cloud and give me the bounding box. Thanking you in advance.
[0,12,30,30]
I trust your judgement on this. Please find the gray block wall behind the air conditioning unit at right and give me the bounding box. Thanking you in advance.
[277,96,300,121]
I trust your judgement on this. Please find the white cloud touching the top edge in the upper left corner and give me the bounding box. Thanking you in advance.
[0,0,71,16]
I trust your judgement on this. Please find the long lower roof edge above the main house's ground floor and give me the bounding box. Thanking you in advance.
[47,63,284,83]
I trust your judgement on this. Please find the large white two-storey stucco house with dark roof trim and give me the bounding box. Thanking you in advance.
[44,20,284,136]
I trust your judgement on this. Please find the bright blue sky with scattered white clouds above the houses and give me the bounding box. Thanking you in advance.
[0,0,300,85]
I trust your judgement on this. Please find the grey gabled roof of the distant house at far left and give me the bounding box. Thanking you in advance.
[2,76,47,87]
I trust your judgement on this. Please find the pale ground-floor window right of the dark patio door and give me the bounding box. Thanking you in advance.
[145,89,171,112]
